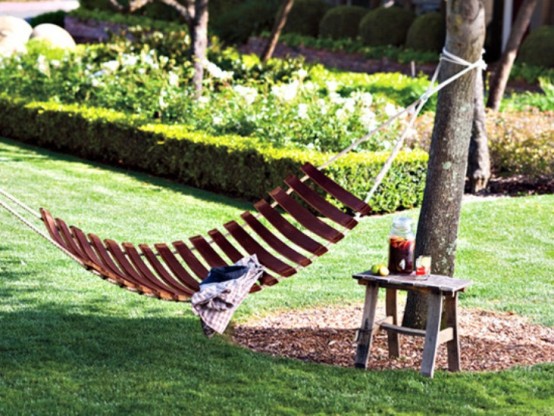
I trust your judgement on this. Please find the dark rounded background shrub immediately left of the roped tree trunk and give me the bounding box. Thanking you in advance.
[406,13,446,52]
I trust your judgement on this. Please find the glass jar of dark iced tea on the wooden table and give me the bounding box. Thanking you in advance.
[389,217,415,274]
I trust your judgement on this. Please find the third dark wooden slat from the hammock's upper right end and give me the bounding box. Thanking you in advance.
[269,187,344,243]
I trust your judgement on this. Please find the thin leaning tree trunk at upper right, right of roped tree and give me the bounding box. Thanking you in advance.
[487,0,536,111]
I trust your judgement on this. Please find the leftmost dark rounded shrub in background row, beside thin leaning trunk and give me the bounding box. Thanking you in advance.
[284,0,329,37]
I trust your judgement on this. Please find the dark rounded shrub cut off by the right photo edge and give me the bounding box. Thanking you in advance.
[517,26,554,68]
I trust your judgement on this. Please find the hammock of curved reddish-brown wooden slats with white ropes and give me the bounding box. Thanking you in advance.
[0,50,484,302]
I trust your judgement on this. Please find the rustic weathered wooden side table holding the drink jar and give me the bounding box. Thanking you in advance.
[352,272,472,377]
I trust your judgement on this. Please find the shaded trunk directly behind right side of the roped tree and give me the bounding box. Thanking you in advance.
[467,74,491,194]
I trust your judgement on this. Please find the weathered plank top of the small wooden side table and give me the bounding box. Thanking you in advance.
[352,271,473,293]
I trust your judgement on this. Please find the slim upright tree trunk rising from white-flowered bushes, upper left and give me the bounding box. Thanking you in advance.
[190,0,208,99]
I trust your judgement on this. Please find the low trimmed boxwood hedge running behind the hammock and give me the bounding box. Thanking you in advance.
[0,95,427,212]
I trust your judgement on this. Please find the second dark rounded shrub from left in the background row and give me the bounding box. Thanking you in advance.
[319,6,368,39]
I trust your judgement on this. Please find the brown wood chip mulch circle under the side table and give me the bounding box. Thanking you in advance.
[232,305,554,371]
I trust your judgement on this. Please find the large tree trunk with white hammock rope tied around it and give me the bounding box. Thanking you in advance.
[403,0,485,328]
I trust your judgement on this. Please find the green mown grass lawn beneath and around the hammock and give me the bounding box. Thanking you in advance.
[0,139,554,415]
